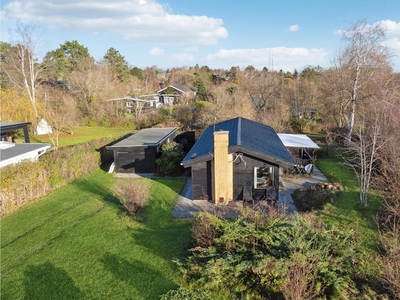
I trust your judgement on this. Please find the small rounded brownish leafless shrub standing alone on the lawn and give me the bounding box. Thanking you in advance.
[114,179,149,215]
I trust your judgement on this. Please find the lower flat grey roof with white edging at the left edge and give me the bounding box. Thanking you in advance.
[0,142,51,166]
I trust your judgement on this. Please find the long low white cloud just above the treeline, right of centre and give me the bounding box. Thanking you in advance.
[205,47,328,71]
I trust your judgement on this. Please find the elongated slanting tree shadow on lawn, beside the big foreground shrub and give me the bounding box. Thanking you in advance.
[100,252,176,299]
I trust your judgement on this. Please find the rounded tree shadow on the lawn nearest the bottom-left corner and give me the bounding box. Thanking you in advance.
[22,261,85,300]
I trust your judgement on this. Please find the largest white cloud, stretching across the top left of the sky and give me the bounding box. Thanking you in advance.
[4,0,228,45]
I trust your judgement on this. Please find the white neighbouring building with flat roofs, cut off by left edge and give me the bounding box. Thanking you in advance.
[0,122,51,168]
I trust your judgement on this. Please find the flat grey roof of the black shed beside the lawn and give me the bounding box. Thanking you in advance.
[106,128,178,150]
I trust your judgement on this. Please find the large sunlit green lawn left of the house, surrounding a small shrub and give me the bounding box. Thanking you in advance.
[1,170,191,299]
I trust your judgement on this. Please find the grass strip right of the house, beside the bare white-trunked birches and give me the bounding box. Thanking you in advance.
[317,152,380,277]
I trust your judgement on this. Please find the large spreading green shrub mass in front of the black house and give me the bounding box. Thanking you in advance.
[177,212,358,299]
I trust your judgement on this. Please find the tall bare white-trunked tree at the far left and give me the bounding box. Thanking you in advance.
[1,24,44,118]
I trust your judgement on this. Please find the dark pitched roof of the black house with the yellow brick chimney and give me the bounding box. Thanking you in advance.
[182,117,295,167]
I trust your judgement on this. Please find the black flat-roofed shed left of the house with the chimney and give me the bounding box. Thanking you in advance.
[106,128,178,173]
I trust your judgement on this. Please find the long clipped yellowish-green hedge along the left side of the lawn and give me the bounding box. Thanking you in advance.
[0,137,115,215]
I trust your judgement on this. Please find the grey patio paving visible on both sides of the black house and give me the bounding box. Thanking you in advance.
[172,166,328,218]
